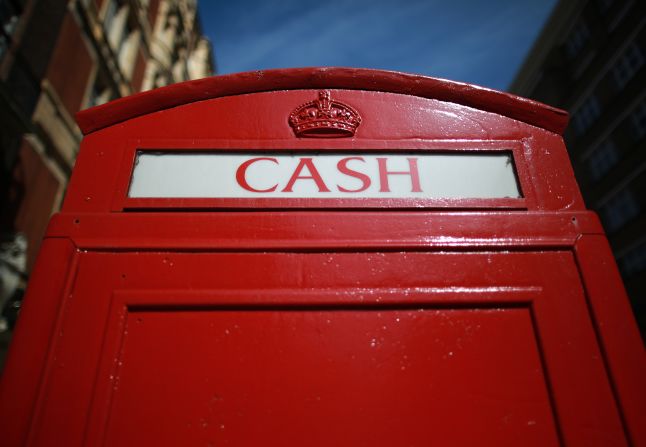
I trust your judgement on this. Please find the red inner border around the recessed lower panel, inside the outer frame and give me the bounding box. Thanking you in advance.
[17,251,623,446]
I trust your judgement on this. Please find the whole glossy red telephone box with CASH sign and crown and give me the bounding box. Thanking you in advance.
[0,69,646,447]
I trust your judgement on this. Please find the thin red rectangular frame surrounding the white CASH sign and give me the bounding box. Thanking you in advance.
[111,139,536,212]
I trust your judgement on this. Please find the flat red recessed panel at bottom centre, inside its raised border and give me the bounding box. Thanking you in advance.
[105,308,558,446]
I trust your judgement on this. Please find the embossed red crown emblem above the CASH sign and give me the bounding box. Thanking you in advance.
[289,90,361,137]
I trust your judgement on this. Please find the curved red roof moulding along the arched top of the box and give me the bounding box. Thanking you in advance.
[77,68,568,135]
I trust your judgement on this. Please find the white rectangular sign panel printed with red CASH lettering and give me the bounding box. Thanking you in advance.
[128,151,521,199]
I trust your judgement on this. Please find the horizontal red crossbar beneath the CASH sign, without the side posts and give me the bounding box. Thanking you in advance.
[48,211,603,251]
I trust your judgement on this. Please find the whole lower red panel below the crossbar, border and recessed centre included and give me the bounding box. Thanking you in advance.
[30,252,625,447]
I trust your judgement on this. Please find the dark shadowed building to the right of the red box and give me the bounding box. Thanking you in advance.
[510,0,646,334]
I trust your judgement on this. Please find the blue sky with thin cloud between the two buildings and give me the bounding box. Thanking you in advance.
[199,0,556,90]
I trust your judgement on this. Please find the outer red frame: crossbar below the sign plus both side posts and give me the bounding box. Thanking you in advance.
[0,212,646,445]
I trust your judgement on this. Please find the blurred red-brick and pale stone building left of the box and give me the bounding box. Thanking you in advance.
[0,0,214,372]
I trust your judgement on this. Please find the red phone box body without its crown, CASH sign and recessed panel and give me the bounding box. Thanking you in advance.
[0,69,646,447]
